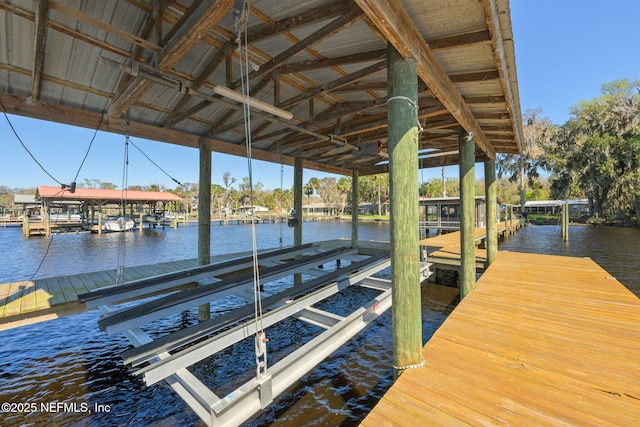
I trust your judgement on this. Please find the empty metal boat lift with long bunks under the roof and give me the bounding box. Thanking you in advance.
[81,240,429,426]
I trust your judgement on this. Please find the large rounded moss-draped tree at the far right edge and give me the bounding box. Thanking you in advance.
[555,79,640,224]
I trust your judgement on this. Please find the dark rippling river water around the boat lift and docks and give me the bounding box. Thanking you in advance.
[0,222,640,426]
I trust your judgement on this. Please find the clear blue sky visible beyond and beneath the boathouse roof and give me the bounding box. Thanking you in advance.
[0,0,640,189]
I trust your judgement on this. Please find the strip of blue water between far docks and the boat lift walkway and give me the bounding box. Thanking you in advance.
[0,221,389,283]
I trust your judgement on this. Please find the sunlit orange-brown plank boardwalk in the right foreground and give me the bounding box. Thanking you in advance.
[362,252,640,427]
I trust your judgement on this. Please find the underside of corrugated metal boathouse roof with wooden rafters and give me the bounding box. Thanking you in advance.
[0,0,525,174]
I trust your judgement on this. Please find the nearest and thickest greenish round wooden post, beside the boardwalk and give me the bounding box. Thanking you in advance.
[387,44,423,377]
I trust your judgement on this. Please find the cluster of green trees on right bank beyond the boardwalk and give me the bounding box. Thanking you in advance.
[498,79,640,224]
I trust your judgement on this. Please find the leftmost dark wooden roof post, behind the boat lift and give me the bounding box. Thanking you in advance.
[198,138,211,322]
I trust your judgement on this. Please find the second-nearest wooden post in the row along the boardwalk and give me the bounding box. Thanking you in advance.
[458,129,476,299]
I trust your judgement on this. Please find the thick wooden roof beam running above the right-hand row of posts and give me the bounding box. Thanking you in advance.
[355,0,496,159]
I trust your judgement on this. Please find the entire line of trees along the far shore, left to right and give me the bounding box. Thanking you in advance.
[0,80,640,222]
